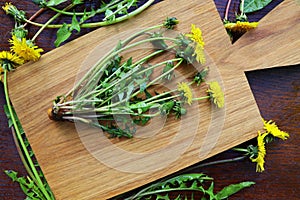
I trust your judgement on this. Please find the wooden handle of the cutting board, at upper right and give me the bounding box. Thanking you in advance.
[224,1,300,71]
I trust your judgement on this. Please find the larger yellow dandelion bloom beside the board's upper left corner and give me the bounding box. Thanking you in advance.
[9,35,44,61]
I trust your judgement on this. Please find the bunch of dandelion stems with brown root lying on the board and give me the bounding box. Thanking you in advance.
[48,17,220,138]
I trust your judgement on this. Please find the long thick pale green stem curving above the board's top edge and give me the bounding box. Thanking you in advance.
[25,0,155,28]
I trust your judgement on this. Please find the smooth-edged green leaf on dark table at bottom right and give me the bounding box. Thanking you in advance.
[216,181,255,199]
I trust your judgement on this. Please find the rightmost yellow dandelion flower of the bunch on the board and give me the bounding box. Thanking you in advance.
[207,81,224,108]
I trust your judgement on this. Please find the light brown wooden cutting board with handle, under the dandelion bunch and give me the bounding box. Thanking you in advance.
[9,0,300,200]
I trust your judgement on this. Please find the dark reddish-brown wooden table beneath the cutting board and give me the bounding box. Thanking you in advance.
[0,0,300,200]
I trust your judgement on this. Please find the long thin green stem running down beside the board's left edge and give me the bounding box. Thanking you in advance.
[3,69,50,199]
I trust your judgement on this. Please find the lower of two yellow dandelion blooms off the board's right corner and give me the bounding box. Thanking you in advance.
[251,131,268,172]
